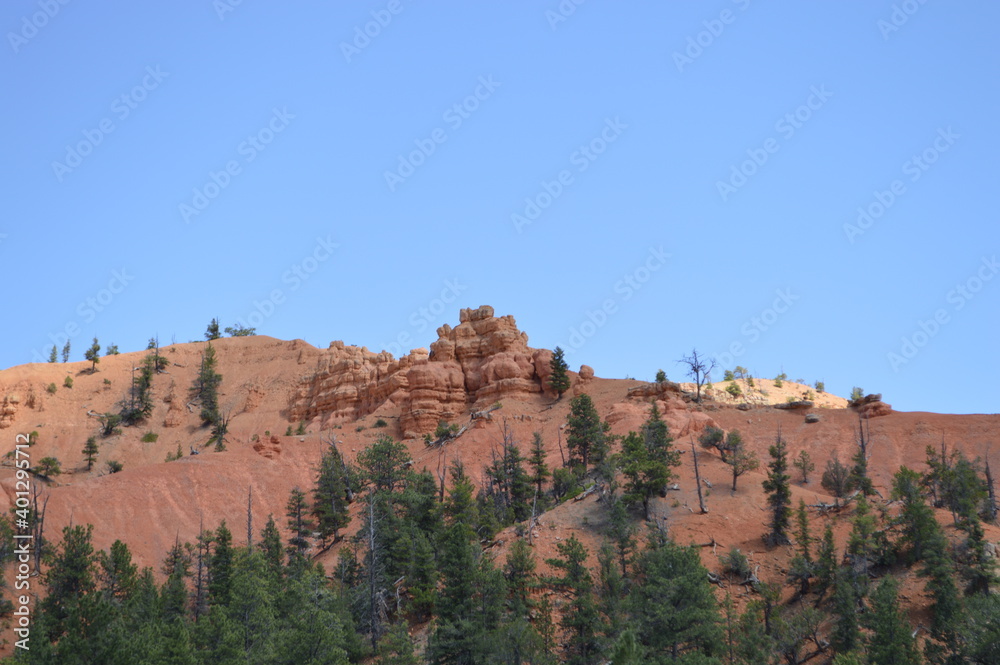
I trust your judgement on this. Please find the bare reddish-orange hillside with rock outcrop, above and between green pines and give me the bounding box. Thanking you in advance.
[0,307,1000,660]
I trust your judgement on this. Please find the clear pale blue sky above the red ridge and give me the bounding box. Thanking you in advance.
[0,0,1000,413]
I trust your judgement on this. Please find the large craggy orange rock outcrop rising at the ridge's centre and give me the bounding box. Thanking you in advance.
[289,306,551,438]
